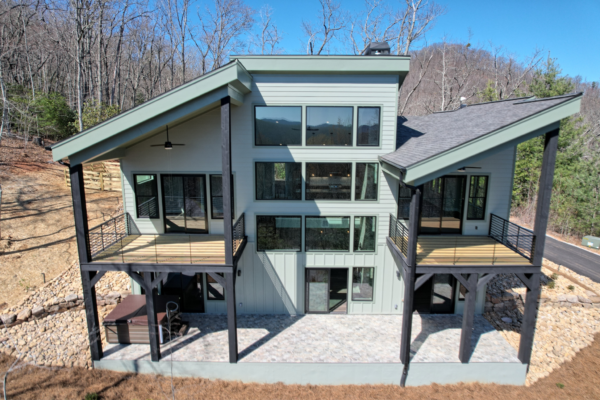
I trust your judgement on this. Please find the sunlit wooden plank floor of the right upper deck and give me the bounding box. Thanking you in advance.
[417,235,531,265]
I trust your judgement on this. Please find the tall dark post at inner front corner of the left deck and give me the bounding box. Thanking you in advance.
[221,97,238,363]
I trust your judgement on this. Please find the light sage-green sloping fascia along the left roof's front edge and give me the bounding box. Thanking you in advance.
[52,63,252,160]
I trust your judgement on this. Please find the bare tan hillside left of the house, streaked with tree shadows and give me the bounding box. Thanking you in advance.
[0,138,121,310]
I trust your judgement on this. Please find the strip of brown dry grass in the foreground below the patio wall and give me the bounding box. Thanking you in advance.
[0,336,600,400]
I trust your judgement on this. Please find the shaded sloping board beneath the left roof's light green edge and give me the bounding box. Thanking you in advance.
[67,86,232,165]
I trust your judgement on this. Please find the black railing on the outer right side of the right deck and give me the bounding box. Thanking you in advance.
[489,214,535,262]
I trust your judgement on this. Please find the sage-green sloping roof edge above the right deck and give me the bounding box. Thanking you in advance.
[379,96,581,186]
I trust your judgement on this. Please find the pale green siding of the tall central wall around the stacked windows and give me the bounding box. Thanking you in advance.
[232,75,402,314]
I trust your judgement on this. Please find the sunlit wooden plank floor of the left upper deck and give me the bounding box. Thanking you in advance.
[92,234,225,264]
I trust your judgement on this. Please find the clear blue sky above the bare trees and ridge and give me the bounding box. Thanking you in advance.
[241,0,600,81]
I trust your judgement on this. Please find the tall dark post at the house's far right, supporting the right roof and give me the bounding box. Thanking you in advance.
[519,129,559,364]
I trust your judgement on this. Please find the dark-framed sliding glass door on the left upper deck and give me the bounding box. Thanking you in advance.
[161,175,208,233]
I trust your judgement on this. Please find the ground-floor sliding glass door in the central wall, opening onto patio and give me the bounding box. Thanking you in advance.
[306,268,348,314]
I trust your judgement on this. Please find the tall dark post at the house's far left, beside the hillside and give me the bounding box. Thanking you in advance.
[69,164,102,361]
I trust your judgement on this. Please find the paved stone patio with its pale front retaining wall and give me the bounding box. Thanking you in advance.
[95,314,525,384]
